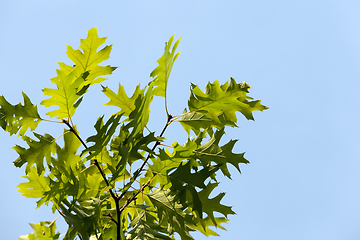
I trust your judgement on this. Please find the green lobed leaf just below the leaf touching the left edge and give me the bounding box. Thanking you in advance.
[13,133,56,174]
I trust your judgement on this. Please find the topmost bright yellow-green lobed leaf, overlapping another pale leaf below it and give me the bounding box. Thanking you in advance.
[66,28,116,90]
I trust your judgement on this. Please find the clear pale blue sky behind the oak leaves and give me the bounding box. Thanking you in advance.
[0,0,360,240]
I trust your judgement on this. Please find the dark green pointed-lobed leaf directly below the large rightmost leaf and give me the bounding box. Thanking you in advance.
[194,129,249,179]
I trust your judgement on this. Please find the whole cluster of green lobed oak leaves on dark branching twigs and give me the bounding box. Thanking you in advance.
[0,28,267,240]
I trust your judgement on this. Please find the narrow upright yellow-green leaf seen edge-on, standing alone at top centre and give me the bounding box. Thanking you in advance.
[149,34,181,98]
